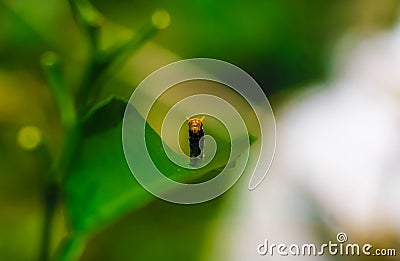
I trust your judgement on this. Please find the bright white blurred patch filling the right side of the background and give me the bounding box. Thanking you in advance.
[210,17,400,261]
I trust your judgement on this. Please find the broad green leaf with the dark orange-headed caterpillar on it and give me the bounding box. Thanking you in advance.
[60,98,258,260]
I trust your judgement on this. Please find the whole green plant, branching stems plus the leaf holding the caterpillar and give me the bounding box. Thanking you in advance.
[32,0,253,260]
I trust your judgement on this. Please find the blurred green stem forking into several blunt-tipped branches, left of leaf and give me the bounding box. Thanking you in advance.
[43,0,167,261]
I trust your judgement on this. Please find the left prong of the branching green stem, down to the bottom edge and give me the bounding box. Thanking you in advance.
[39,52,80,261]
